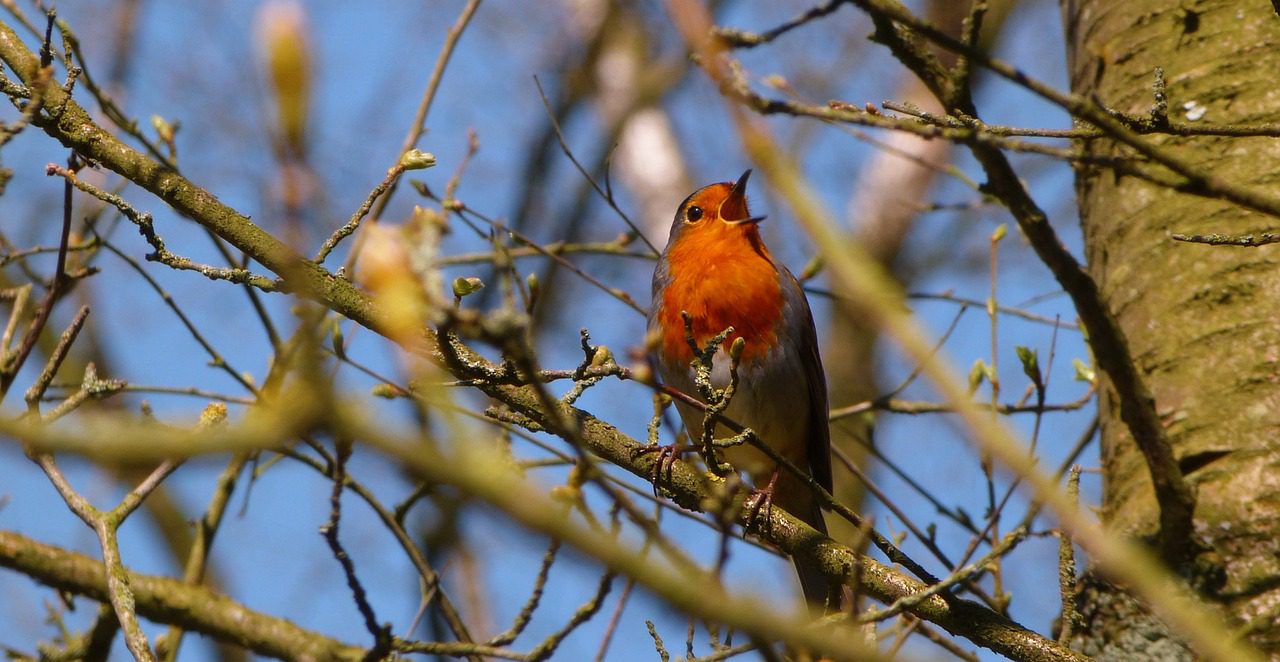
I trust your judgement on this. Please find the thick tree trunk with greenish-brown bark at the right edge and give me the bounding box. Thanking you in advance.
[1062,0,1280,659]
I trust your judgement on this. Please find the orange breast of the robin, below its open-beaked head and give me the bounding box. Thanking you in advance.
[654,227,782,362]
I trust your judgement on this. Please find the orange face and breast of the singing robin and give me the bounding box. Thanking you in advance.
[655,170,782,361]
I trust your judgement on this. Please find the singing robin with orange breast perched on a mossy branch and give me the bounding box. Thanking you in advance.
[649,170,831,608]
